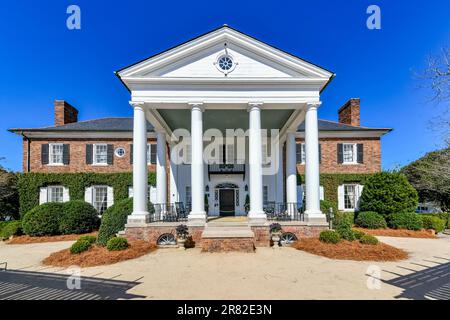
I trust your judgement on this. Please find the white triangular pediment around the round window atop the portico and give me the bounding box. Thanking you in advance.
[118,26,333,80]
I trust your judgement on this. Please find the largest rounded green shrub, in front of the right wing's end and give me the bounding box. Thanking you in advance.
[359,172,418,216]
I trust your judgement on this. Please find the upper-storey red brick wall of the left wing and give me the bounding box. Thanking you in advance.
[23,139,156,173]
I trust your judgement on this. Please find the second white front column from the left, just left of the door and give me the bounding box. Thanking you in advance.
[189,103,206,221]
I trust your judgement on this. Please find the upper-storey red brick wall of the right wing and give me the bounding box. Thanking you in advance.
[297,138,381,173]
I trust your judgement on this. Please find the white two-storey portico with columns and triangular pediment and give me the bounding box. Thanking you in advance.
[117,26,333,228]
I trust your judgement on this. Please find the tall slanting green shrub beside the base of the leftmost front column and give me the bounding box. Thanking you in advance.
[97,198,133,246]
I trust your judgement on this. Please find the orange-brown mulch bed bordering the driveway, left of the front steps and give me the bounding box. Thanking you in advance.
[42,241,156,267]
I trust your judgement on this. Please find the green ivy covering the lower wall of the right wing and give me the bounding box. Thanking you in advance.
[297,173,372,207]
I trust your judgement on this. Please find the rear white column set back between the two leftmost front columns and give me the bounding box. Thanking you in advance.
[156,132,167,204]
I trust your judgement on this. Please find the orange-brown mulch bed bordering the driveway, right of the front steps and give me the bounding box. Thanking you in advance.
[293,238,408,261]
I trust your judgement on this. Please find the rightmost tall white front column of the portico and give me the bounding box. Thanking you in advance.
[305,103,326,222]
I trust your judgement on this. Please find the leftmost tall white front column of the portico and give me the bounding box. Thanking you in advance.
[128,102,149,223]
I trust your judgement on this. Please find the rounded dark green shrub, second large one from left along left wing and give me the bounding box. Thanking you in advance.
[59,200,100,234]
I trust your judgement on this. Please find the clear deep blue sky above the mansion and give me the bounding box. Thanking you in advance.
[0,0,450,170]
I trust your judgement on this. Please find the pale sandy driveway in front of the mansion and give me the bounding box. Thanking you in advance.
[0,236,450,299]
